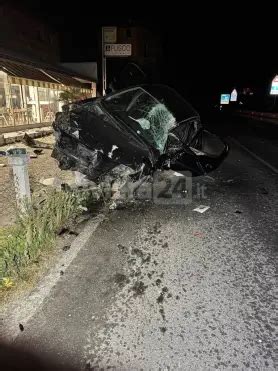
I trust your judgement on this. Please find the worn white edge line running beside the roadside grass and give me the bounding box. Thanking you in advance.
[1,214,105,342]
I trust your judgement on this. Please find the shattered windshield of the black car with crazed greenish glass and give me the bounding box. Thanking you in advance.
[105,88,176,153]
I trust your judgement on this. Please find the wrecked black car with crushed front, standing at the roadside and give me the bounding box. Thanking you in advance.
[52,85,228,182]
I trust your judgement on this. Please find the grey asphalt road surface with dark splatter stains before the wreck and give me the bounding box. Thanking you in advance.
[1,129,278,370]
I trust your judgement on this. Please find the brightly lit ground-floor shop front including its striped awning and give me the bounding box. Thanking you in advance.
[0,59,95,127]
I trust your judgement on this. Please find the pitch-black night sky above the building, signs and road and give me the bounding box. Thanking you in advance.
[11,0,278,107]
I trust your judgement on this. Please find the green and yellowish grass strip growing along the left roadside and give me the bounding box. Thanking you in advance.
[0,191,88,293]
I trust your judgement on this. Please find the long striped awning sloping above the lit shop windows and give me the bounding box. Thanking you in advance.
[0,58,91,89]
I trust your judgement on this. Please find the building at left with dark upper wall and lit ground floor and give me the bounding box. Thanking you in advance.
[0,2,96,128]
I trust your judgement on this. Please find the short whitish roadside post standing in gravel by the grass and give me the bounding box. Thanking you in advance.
[8,148,31,210]
